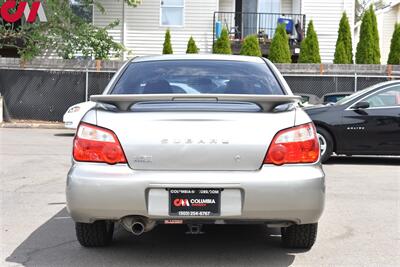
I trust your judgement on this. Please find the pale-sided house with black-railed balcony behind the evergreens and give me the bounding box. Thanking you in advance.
[93,0,355,62]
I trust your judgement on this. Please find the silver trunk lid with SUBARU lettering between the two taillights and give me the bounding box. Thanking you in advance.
[91,94,295,171]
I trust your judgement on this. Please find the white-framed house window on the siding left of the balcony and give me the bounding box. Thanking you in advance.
[161,0,185,26]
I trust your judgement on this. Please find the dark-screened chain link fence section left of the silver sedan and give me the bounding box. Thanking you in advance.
[0,69,114,121]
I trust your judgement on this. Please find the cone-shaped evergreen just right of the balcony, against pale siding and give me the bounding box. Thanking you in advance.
[299,20,321,63]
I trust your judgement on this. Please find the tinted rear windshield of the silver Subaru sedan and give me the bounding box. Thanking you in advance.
[111,60,284,95]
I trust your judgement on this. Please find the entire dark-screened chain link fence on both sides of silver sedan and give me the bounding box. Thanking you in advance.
[0,69,400,121]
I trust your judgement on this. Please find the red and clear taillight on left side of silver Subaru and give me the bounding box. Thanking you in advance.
[73,123,126,164]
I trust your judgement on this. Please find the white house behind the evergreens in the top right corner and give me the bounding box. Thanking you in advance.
[354,1,400,64]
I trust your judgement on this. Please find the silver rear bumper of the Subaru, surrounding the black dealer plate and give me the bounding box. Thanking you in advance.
[66,163,325,224]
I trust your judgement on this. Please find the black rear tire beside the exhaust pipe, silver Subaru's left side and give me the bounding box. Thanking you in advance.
[75,221,114,247]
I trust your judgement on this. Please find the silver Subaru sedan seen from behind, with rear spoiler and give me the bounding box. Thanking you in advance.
[66,55,325,249]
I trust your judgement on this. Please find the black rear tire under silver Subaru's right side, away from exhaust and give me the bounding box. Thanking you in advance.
[281,223,318,249]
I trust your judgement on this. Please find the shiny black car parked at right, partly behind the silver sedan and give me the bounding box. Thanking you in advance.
[305,81,400,162]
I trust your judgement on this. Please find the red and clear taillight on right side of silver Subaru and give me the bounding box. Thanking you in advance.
[264,123,320,165]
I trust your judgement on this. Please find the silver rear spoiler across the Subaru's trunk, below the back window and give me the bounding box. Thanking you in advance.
[90,94,301,112]
